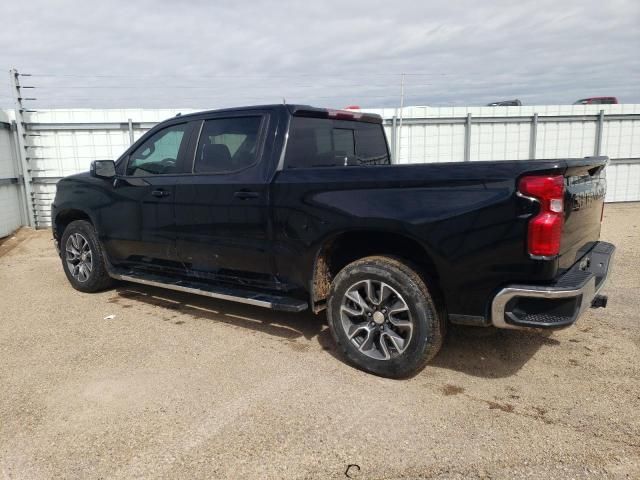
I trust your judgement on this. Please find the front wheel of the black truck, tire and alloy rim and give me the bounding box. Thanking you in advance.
[60,220,113,293]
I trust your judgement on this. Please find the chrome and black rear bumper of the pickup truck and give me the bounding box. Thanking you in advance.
[491,242,616,329]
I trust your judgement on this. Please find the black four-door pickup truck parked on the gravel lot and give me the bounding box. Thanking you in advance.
[52,105,615,377]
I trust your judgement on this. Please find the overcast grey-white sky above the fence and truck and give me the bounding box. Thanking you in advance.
[0,0,640,109]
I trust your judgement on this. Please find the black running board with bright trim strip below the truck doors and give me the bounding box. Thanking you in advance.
[109,269,308,312]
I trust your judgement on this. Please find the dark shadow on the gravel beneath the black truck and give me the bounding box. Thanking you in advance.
[108,285,560,378]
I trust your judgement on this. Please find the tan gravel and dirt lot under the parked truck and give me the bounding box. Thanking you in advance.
[0,204,640,479]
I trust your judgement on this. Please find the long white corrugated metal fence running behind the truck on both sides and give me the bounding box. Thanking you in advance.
[0,105,640,231]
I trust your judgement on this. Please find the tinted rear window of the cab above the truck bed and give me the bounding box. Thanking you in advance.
[284,116,391,168]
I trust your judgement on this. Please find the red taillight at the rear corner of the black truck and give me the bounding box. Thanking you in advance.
[518,175,564,257]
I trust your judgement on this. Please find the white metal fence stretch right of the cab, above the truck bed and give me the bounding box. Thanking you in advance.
[376,104,640,202]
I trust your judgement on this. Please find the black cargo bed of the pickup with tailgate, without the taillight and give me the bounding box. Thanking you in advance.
[271,157,608,319]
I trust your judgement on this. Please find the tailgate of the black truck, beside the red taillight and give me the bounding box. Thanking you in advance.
[559,157,608,269]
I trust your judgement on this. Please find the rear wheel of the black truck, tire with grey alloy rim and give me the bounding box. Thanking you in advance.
[327,256,445,378]
